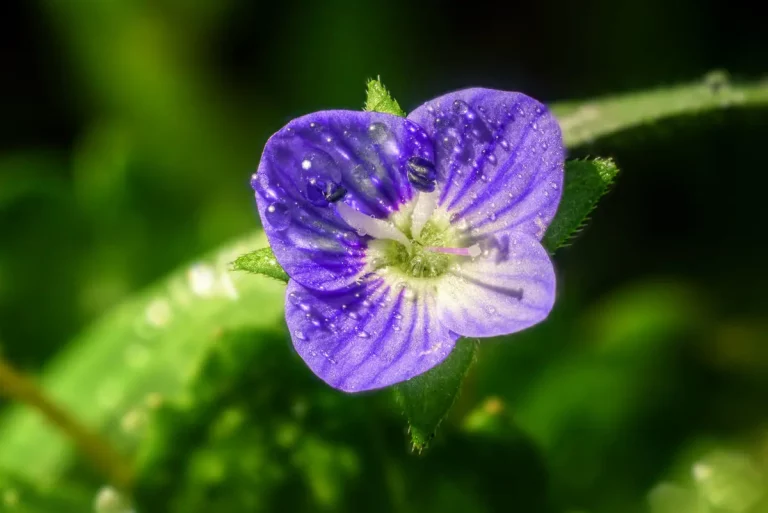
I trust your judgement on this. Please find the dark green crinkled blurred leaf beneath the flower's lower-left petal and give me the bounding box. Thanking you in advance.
[135,329,380,513]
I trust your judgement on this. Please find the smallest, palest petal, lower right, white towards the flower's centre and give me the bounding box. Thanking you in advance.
[436,232,555,337]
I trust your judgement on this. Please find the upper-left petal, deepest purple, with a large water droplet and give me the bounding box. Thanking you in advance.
[252,111,434,290]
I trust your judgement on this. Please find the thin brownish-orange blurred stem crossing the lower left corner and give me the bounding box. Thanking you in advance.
[0,357,132,490]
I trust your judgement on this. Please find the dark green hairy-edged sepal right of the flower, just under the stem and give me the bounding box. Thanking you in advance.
[542,158,619,253]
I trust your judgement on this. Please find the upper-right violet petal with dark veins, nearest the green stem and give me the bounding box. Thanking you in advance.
[408,88,565,239]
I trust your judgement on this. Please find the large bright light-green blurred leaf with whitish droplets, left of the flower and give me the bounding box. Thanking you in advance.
[0,234,285,482]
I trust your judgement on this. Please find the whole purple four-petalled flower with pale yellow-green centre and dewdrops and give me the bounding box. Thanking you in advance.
[252,89,564,392]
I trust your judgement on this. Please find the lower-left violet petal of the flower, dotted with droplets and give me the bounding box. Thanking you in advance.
[285,275,458,392]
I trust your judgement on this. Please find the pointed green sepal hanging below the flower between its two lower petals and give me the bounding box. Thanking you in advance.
[394,339,477,451]
